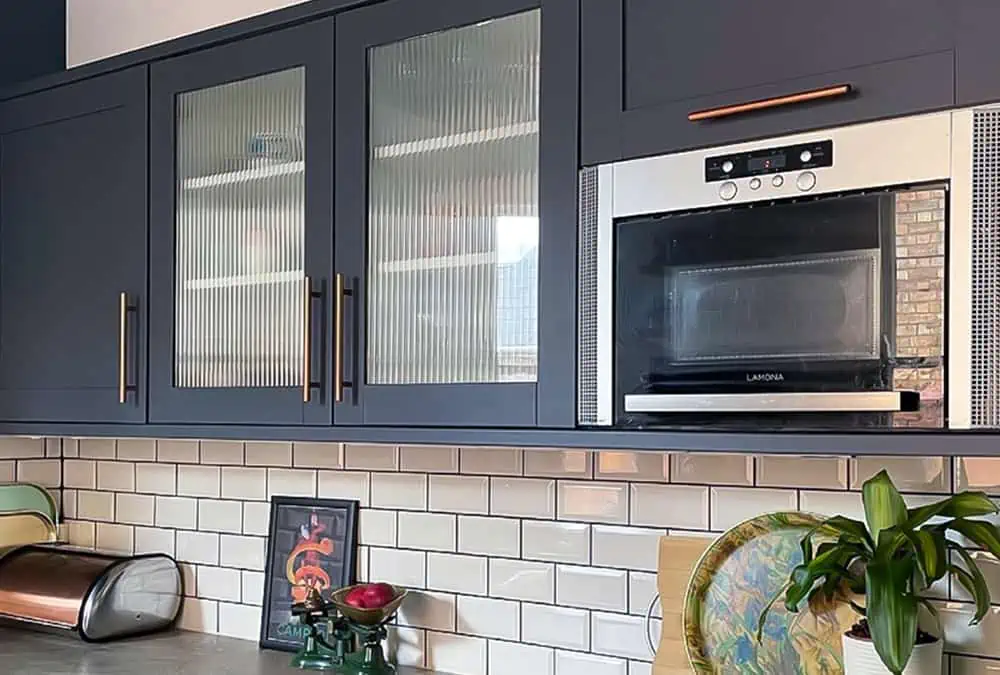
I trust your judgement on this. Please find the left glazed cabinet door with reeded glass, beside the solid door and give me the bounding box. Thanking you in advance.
[150,21,334,424]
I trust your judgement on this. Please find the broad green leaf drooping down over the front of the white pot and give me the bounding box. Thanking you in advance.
[865,556,917,675]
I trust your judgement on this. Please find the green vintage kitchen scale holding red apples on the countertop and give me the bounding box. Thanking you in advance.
[292,586,406,675]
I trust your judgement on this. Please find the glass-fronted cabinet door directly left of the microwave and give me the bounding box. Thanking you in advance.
[334,0,576,426]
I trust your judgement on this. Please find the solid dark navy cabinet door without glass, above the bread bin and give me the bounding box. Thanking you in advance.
[0,66,149,422]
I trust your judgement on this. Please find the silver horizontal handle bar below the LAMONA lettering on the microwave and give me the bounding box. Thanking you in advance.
[625,391,903,413]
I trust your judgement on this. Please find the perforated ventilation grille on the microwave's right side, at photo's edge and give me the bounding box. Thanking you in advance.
[972,110,1000,427]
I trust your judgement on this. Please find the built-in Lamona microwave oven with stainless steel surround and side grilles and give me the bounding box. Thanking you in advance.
[578,109,1000,429]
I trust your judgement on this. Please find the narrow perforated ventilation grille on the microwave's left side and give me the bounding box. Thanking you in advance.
[577,168,598,424]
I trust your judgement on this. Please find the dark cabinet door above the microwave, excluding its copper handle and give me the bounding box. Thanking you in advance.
[582,0,954,164]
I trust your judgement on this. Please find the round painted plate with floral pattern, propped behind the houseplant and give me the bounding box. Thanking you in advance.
[684,512,857,675]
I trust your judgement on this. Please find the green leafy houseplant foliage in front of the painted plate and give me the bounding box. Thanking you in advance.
[757,471,1000,675]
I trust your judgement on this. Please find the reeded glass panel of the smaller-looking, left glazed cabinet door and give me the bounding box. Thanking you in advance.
[174,68,305,387]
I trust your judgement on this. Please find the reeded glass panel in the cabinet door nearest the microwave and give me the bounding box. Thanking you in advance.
[367,11,540,384]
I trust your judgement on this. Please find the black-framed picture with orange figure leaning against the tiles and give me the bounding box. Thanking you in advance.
[260,497,359,651]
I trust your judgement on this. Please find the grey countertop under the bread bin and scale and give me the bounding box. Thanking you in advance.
[0,628,438,675]
